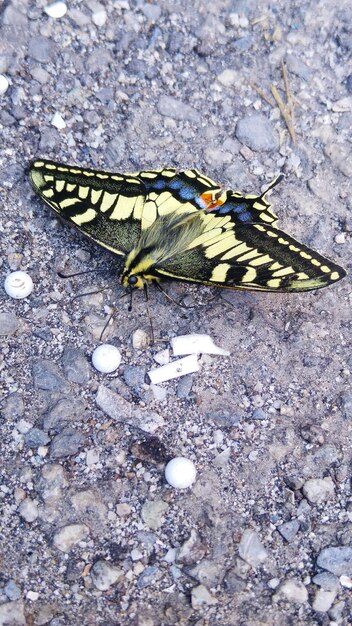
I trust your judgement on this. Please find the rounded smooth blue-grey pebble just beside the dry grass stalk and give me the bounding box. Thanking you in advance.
[236,113,279,152]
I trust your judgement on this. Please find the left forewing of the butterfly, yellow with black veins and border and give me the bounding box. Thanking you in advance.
[30,160,147,255]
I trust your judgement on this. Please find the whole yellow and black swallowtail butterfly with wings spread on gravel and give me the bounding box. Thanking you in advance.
[30,159,346,292]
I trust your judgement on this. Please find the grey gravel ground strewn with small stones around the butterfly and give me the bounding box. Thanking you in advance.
[0,0,352,626]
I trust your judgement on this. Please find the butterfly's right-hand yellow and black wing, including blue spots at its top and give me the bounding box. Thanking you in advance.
[154,186,346,292]
